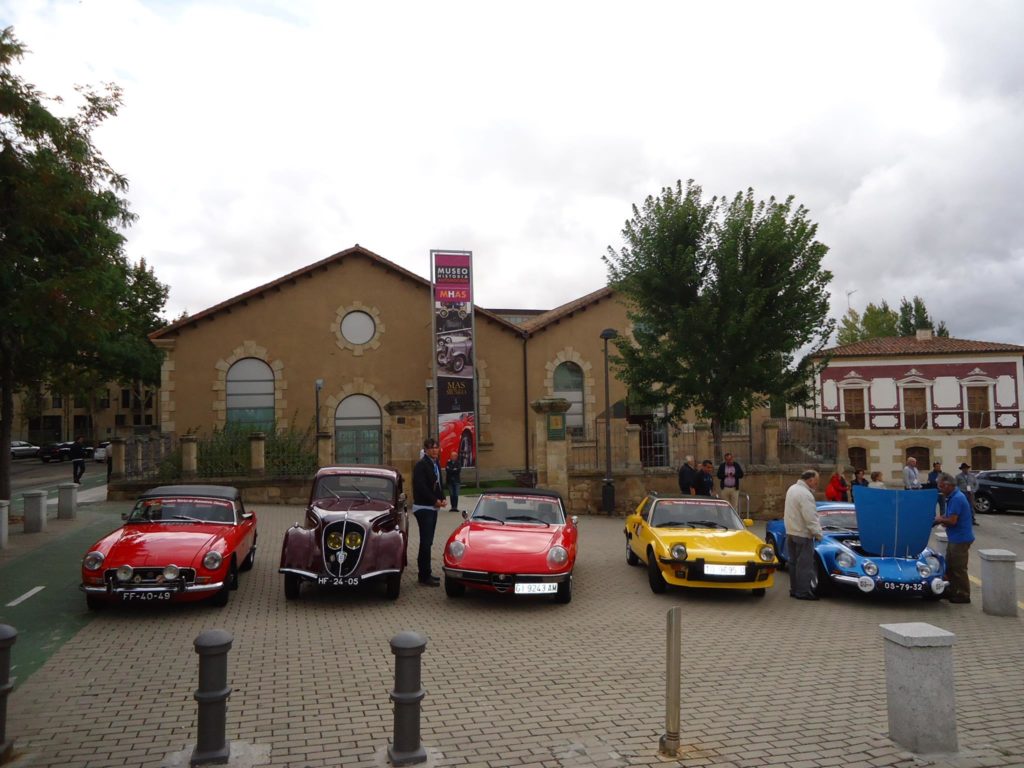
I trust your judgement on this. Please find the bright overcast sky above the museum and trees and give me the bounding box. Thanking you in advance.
[8,0,1024,344]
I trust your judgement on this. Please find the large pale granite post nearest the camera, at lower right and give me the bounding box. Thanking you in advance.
[879,622,957,755]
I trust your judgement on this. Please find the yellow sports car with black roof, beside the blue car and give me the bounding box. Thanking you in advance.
[625,494,778,597]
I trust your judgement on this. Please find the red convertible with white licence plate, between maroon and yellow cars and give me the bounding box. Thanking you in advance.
[443,488,578,603]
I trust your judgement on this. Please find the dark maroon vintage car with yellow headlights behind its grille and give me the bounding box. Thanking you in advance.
[280,464,409,600]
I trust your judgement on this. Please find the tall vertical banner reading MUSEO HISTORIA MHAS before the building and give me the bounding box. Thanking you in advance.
[430,251,476,468]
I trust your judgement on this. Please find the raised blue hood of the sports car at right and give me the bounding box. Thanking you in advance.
[853,487,938,557]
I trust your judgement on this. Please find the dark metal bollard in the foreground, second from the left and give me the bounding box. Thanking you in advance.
[188,630,234,765]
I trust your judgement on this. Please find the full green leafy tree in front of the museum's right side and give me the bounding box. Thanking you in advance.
[604,180,835,456]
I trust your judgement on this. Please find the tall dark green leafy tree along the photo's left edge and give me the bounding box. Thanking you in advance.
[0,28,167,499]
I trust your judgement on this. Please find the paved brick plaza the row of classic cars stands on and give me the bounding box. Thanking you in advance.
[7,504,1024,768]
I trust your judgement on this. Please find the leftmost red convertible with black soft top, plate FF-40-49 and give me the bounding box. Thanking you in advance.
[81,485,256,610]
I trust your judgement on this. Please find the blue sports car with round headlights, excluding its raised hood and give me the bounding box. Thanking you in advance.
[765,502,947,600]
